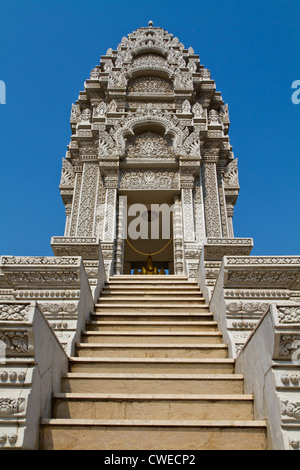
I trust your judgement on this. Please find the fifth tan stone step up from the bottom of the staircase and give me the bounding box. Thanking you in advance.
[76,343,228,358]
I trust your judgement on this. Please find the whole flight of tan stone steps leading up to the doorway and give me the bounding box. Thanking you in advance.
[40,275,267,450]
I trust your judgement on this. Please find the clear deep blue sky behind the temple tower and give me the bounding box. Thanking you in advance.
[0,0,300,256]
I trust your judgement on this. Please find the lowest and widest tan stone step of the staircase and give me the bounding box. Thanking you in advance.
[40,419,267,451]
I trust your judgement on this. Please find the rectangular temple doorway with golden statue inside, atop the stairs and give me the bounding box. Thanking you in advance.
[119,190,175,274]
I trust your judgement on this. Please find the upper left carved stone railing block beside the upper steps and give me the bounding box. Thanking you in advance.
[0,256,104,356]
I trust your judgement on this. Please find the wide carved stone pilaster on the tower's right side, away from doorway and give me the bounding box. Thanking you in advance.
[201,155,222,237]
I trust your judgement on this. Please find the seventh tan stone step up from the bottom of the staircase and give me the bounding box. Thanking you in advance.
[86,317,218,332]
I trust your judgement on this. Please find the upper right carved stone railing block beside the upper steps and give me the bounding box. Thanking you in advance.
[209,256,300,357]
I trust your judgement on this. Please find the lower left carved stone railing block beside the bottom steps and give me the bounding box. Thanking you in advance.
[0,300,68,450]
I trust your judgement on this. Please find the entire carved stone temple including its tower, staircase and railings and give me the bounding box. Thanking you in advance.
[0,22,300,451]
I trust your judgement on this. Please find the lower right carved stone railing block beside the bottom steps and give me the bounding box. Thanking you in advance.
[236,302,300,450]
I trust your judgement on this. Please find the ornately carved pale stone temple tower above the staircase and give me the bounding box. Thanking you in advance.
[52,22,239,278]
